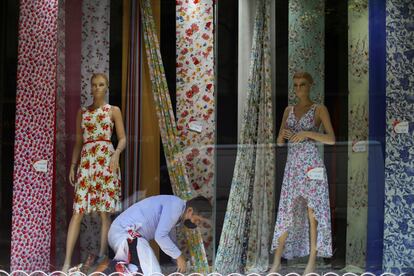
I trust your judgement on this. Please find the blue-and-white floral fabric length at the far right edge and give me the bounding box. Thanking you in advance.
[383,0,414,274]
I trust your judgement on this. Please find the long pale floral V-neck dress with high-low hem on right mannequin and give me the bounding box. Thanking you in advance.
[272,104,332,259]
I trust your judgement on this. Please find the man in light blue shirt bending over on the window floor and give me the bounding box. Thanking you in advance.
[108,195,211,275]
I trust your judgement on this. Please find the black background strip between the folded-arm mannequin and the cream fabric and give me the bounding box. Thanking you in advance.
[324,0,348,268]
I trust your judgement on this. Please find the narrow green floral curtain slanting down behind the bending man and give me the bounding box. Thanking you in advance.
[141,0,208,273]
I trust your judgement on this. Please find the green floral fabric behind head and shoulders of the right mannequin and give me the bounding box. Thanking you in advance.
[288,0,325,104]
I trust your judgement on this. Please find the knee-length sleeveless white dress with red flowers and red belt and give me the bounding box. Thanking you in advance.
[73,104,122,213]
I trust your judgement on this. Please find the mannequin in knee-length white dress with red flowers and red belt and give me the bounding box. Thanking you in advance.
[62,73,126,272]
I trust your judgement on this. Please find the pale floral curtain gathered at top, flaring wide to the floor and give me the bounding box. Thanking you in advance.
[215,0,275,274]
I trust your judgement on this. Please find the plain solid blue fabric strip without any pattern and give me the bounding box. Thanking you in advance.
[366,0,387,274]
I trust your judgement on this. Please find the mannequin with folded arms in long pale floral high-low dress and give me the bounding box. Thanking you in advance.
[270,72,335,275]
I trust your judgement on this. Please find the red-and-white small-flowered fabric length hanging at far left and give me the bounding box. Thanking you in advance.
[10,0,58,273]
